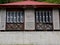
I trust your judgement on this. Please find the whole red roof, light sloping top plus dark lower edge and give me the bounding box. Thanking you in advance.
[0,1,60,7]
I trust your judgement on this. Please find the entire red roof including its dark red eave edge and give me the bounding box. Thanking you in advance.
[0,0,60,8]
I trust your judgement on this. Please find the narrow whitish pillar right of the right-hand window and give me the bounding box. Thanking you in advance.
[53,9,59,30]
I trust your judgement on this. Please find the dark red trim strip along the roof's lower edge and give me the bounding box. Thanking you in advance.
[0,5,60,8]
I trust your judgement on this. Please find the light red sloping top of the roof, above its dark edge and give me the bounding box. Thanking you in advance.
[3,1,56,5]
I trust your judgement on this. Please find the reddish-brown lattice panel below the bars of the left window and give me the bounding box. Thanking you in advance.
[6,23,24,30]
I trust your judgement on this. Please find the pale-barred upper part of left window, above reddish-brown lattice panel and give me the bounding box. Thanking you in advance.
[7,11,23,23]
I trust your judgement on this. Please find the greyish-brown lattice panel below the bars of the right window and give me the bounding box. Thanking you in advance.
[36,23,53,30]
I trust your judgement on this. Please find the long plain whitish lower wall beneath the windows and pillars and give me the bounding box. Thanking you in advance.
[0,32,60,45]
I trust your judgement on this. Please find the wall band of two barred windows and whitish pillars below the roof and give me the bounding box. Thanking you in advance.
[0,9,59,31]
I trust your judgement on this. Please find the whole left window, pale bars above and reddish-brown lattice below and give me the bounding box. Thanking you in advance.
[6,10,24,30]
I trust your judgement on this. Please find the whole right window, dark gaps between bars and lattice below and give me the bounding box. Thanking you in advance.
[35,10,53,30]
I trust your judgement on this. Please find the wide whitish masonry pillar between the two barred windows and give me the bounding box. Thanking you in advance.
[24,9,35,30]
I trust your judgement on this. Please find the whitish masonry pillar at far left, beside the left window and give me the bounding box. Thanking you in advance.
[0,9,6,30]
